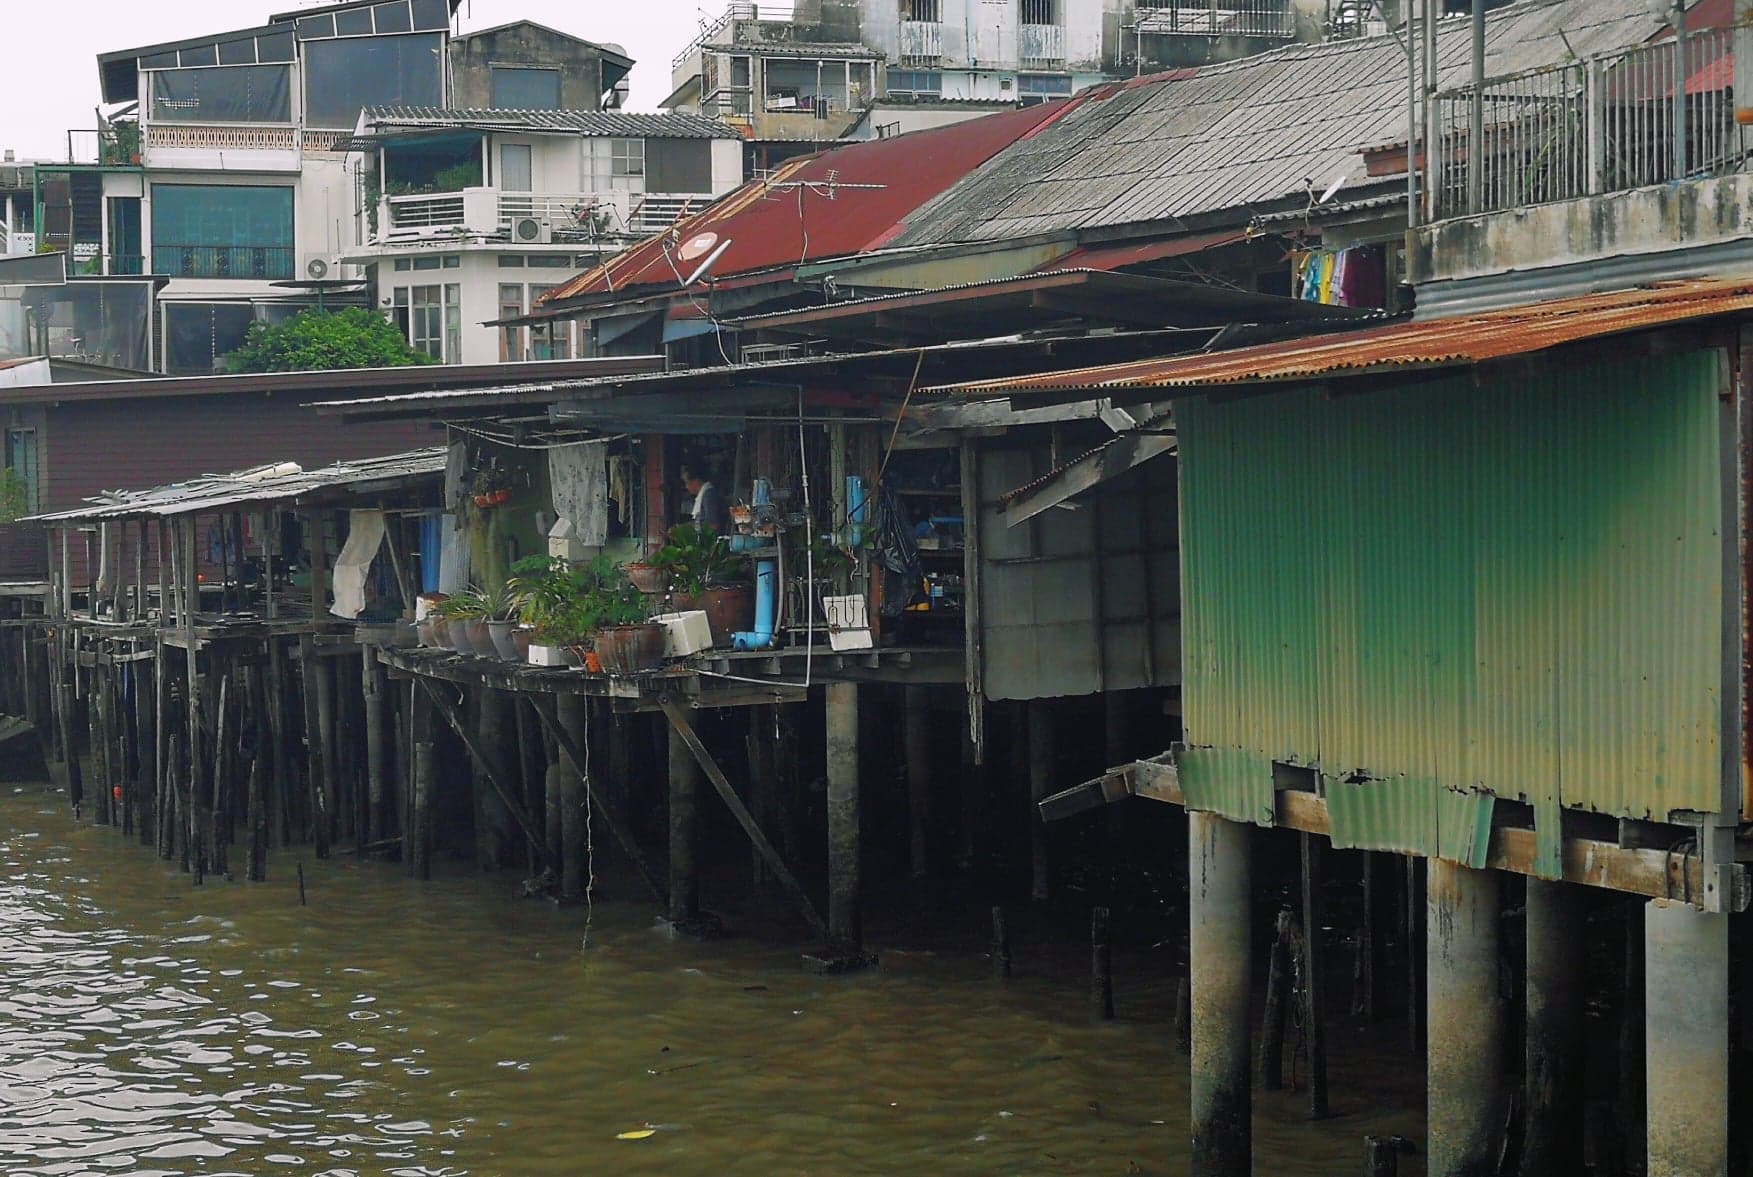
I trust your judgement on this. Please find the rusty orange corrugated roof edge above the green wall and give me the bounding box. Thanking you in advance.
[926,279,1753,396]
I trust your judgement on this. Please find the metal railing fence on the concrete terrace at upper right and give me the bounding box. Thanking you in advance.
[1427,30,1742,219]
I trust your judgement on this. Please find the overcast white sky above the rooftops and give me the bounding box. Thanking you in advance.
[0,0,767,160]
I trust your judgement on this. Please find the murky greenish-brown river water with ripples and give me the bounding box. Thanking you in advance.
[0,786,1418,1177]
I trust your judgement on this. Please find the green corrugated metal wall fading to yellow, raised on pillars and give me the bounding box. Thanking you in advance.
[1176,351,1725,841]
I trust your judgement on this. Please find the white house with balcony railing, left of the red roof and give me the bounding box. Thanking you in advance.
[344,107,743,363]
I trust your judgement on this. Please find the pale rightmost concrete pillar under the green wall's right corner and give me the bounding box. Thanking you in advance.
[1644,900,1728,1177]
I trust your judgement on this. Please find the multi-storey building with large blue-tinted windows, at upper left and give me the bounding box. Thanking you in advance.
[75,0,659,374]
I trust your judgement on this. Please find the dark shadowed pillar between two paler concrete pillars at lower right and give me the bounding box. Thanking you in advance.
[1522,879,1586,1177]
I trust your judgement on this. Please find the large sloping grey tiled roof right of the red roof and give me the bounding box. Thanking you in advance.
[891,0,1664,246]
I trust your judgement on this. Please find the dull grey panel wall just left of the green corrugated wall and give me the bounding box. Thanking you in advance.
[980,446,1180,700]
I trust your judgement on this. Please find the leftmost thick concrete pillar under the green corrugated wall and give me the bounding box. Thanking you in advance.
[1187,812,1253,1177]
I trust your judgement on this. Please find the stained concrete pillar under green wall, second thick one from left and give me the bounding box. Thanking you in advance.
[1425,858,1504,1177]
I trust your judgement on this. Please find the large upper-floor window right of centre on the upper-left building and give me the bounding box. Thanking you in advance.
[305,33,444,130]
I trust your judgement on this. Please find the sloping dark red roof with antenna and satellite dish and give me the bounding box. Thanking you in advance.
[543,98,1082,303]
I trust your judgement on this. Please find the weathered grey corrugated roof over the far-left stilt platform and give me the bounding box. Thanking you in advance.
[25,446,447,523]
